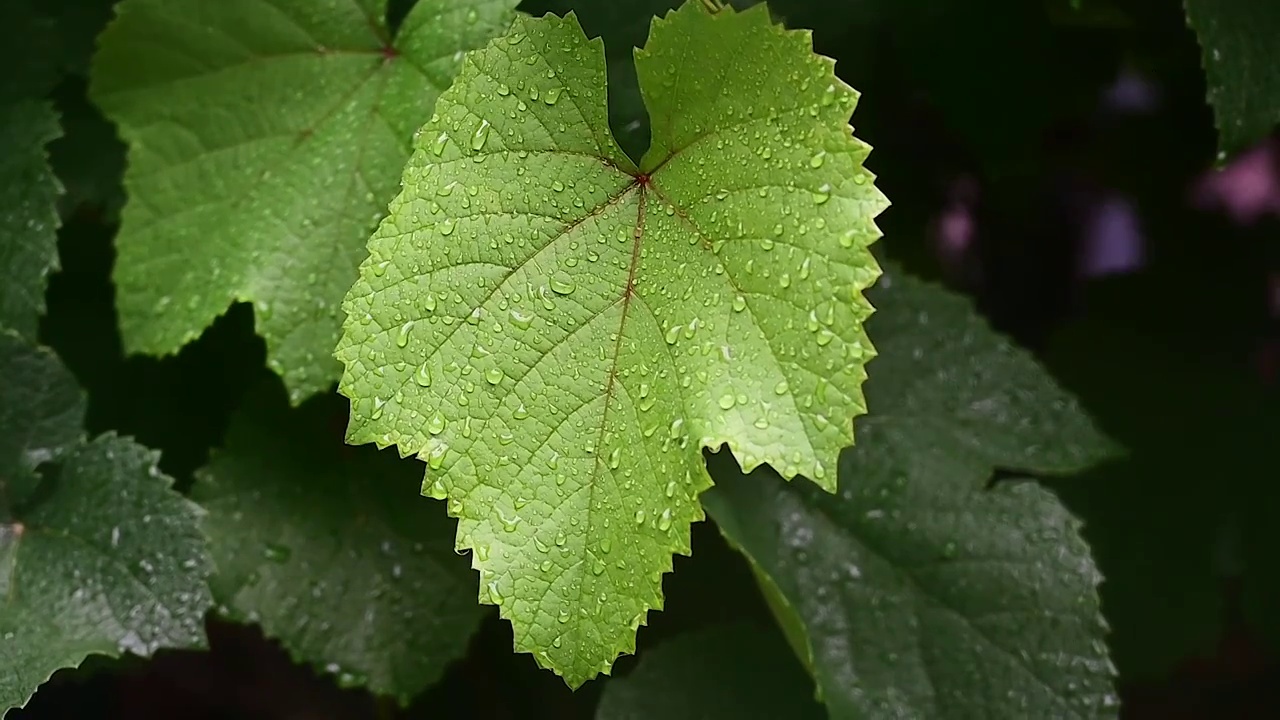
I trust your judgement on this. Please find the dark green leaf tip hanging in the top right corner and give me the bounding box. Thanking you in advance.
[1184,0,1280,160]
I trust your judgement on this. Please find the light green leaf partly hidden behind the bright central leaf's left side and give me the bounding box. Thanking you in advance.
[90,0,515,402]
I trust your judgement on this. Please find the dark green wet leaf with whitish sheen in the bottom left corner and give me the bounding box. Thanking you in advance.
[0,333,212,708]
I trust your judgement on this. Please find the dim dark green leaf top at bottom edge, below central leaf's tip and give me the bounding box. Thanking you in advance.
[595,623,827,720]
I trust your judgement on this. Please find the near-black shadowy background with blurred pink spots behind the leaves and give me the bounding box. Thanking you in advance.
[13,0,1280,720]
